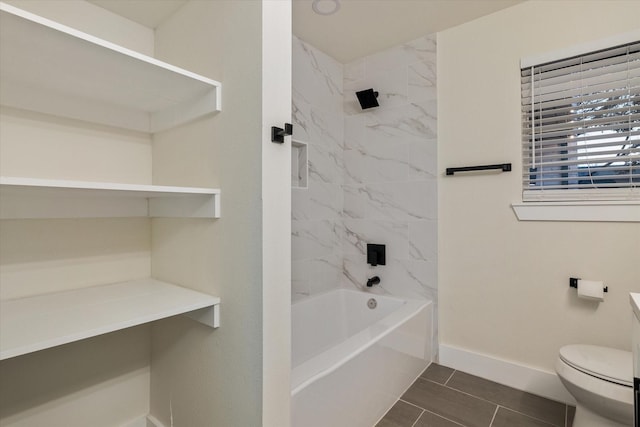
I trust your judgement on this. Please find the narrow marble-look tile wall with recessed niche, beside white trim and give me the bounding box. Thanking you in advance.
[291,37,344,298]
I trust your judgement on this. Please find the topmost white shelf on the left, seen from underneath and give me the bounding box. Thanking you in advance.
[0,2,221,133]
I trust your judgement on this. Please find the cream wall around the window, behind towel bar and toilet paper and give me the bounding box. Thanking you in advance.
[438,1,640,380]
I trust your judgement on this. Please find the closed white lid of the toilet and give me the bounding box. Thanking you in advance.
[560,344,633,387]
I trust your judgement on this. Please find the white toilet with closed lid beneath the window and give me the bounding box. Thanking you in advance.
[556,344,633,427]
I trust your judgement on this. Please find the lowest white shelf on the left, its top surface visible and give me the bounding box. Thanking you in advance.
[0,279,220,360]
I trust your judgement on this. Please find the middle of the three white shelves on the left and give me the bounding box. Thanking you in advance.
[0,177,220,219]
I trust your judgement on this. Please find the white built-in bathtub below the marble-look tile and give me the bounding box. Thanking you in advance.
[291,289,432,427]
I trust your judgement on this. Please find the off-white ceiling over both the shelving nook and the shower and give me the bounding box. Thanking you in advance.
[88,0,525,63]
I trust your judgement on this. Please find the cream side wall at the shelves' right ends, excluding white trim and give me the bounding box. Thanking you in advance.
[151,1,262,426]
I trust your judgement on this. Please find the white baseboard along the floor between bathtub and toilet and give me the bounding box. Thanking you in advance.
[439,344,576,405]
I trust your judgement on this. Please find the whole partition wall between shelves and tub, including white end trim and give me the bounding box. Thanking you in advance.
[151,1,291,427]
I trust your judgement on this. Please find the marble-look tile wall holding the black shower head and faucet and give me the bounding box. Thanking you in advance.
[342,35,438,358]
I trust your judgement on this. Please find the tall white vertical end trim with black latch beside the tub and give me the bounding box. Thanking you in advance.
[262,1,292,427]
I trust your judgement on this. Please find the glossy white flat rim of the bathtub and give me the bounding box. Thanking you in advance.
[291,288,433,397]
